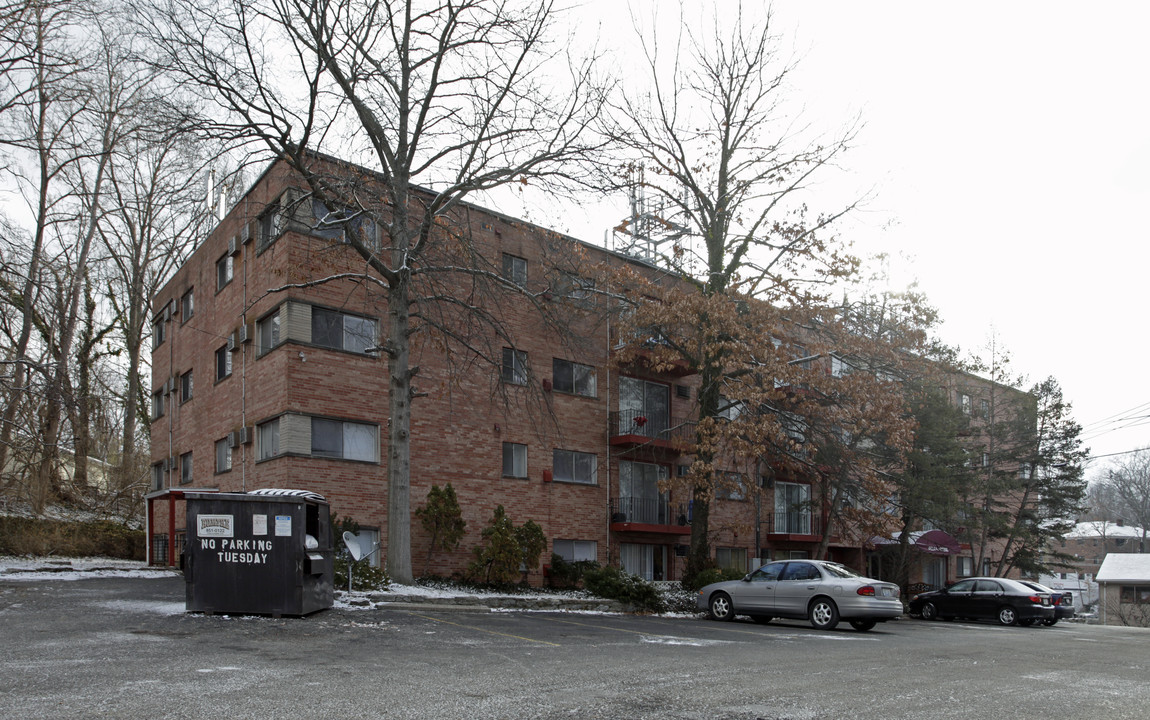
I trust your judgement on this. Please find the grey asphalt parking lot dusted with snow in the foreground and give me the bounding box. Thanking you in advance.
[0,576,1150,720]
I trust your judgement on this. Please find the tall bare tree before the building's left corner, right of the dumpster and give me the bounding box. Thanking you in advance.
[140,0,601,582]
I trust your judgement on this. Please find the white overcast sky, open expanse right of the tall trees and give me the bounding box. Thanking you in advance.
[549,0,1150,474]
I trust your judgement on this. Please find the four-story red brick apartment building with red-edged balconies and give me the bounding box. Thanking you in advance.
[148,156,1021,582]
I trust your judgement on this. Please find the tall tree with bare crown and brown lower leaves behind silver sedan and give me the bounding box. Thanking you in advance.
[612,7,857,576]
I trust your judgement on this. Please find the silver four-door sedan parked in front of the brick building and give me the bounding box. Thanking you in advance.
[697,560,903,631]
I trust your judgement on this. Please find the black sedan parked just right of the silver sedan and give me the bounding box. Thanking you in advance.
[910,577,1056,626]
